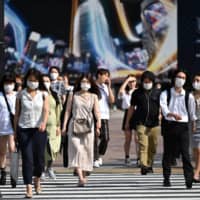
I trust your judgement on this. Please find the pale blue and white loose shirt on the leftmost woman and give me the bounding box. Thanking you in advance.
[0,92,17,135]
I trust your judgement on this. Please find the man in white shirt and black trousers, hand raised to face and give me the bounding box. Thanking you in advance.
[94,68,115,167]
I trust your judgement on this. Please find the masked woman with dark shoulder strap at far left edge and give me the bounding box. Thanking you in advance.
[0,73,16,185]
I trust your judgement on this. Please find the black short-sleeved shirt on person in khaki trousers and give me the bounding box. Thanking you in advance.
[130,88,161,129]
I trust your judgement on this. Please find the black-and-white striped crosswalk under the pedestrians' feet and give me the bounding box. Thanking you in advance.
[0,173,200,200]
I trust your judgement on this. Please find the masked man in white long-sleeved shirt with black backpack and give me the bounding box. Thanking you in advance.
[160,70,197,189]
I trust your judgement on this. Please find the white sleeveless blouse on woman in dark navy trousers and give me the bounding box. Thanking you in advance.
[17,89,48,128]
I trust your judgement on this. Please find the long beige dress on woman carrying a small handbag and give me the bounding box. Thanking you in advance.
[68,93,95,171]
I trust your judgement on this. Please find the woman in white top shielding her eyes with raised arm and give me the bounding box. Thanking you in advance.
[118,74,137,165]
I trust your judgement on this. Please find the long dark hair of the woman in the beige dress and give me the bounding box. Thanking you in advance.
[74,74,101,99]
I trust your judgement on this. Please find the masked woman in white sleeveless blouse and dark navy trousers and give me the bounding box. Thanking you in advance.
[15,69,49,198]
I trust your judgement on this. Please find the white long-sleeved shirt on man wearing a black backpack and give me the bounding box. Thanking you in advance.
[160,88,197,122]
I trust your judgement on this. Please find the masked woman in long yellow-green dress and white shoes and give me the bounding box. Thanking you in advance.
[41,75,62,180]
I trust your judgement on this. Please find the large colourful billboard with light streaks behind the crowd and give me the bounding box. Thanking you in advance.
[5,0,177,78]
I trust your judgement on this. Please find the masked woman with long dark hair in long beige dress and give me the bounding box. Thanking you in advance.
[62,75,101,187]
